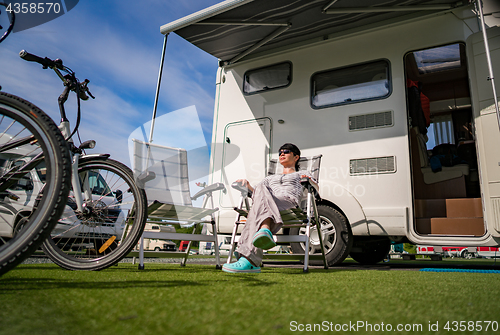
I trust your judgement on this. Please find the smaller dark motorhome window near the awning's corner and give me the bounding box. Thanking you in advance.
[243,62,292,94]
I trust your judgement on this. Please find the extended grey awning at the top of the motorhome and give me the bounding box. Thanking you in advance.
[160,0,470,64]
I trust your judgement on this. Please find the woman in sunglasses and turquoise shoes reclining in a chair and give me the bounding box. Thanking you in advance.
[222,143,314,273]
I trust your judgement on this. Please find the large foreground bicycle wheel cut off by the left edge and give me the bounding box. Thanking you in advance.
[0,92,71,275]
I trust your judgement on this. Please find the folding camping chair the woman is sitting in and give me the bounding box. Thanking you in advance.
[227,155,328,272]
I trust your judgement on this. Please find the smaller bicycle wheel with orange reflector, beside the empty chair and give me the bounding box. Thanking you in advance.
[43,157,147,270]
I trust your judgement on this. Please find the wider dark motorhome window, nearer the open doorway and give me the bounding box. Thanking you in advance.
[311,60,391,108]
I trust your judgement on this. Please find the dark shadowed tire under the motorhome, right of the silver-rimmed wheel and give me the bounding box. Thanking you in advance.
[349,236,391,264]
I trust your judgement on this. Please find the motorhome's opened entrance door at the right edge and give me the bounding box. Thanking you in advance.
[466,27,500,237]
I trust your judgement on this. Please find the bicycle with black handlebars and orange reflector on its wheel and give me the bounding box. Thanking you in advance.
[20,50,147,270]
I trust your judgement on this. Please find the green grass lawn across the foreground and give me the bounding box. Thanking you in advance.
[0,263,500,335]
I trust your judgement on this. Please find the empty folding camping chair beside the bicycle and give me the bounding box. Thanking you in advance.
[130,139,226,269]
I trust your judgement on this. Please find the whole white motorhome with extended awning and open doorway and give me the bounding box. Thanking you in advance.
[156,0,500,265]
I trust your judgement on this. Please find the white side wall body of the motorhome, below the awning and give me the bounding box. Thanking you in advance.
[159,1,500,266]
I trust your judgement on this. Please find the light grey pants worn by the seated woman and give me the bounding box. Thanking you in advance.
[236,183,295,265]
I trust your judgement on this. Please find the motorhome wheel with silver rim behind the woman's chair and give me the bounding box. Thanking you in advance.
[289,205,352,266]
